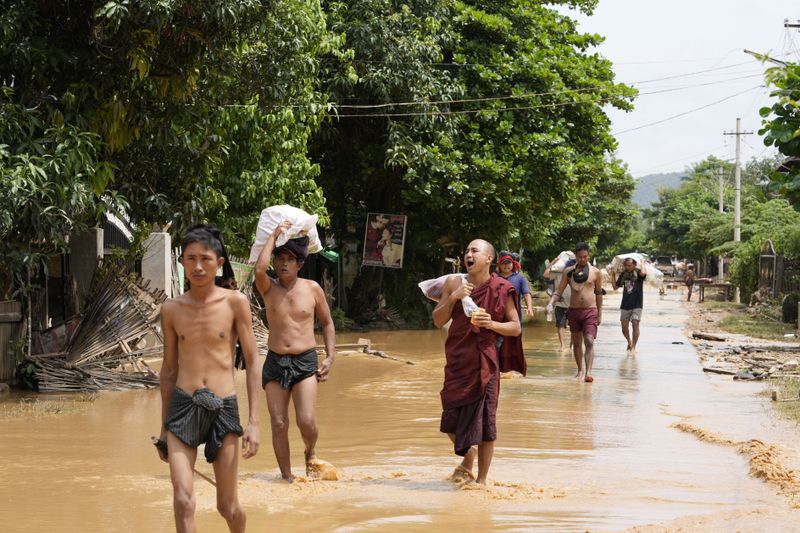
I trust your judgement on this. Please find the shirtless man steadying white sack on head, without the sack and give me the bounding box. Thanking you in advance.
[255,221,336,481]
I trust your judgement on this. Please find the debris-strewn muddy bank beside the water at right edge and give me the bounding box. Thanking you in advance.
[685,302,800,379]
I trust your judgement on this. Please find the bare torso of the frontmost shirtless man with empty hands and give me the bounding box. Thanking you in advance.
[162,289,239,397]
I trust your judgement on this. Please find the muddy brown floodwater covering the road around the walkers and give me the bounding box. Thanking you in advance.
[0,293,798,532]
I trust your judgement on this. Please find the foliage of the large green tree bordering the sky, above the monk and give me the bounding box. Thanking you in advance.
[314,0,634,316]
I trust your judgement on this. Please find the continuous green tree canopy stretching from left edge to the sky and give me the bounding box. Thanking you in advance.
[0,0,635,320]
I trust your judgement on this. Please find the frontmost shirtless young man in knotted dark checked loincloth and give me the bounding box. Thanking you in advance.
[156,226,259,531]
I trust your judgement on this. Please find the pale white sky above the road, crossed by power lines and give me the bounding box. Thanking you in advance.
[571,0,800,177]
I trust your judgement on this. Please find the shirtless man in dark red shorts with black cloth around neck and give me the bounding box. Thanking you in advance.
[547,242,603,383]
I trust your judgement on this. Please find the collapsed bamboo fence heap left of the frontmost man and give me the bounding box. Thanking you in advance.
[30,262,166,392]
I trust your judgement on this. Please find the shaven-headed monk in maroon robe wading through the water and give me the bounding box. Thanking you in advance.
[433,239,526,485]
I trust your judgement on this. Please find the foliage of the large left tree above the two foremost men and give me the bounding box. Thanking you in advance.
[0,0,336,260]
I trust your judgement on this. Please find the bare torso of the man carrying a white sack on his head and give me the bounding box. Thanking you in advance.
[264,278,317,355]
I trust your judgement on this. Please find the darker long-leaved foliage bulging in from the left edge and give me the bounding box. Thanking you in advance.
[0,87,125,285]
